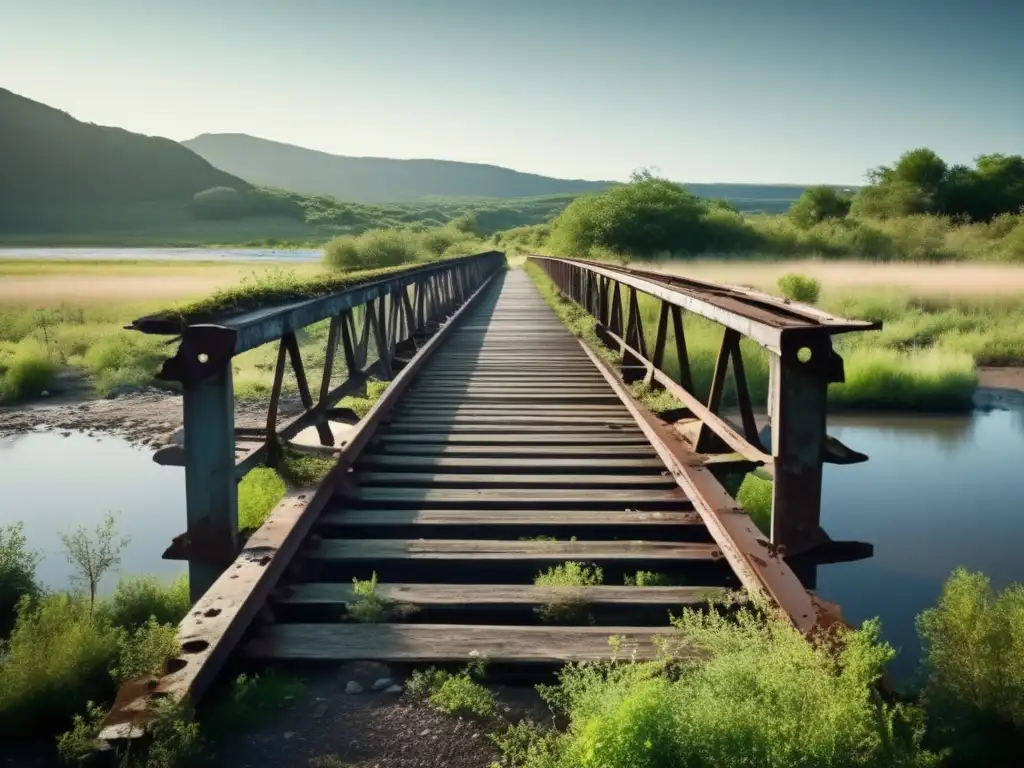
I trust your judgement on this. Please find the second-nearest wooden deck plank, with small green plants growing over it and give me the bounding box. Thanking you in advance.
[283,582,728,607]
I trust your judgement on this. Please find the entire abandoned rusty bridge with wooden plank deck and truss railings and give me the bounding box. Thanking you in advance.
[101,252,878,740]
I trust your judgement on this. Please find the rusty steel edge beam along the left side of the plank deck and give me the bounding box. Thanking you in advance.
[98,264,505,743]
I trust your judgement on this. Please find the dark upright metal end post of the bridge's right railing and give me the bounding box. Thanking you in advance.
[768,337,831,552]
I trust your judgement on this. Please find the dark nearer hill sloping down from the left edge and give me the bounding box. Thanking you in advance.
[0,88,249,217]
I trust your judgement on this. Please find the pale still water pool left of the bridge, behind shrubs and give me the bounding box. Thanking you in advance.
[0,432,185,594]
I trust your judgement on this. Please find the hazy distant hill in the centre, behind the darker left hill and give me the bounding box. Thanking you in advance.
[182,133,612,203]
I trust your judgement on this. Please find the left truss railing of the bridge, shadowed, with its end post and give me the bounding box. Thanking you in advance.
[133,252,505,601]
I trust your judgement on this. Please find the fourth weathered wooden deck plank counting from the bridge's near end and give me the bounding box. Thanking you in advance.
[318,504,703,528]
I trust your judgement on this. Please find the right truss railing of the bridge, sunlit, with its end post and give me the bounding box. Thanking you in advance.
[530,256,881,558]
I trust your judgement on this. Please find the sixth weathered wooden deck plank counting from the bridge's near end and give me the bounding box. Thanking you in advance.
[354,472,676,489]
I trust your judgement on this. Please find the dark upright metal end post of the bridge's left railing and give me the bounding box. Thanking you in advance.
[182,358,239,603]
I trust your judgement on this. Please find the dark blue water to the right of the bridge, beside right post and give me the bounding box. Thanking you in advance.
[818,411,1024,680]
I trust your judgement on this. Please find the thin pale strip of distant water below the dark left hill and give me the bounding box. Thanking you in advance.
[0,247,324,261]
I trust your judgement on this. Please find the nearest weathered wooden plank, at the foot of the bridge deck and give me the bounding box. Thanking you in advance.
[243,624,675,664]
